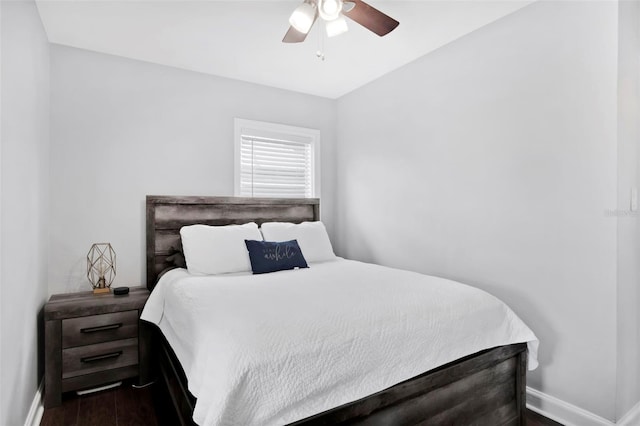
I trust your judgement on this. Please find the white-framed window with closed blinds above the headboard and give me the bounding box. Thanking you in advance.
[235,118,320,198]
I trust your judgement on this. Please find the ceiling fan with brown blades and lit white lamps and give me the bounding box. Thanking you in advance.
[282,0,400,43]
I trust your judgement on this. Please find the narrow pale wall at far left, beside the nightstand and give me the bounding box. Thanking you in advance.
[0,1,49,425]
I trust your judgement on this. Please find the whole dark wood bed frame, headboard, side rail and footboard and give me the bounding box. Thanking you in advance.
[147,196,527,426]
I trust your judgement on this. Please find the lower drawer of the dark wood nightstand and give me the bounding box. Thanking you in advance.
[62,338,138,379]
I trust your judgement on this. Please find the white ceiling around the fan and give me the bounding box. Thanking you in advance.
[37,0,532,98]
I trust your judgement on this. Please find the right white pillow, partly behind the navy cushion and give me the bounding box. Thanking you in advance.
[260,221,336,262]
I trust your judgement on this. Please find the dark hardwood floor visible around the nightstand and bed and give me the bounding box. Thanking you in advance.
[40,382,562,426]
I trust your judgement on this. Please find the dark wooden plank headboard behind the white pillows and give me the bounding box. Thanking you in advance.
[147,195,320,290]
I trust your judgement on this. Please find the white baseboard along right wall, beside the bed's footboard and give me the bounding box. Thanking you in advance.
[527,386,616,426]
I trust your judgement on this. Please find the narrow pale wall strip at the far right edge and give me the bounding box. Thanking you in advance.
[616,1,640,419]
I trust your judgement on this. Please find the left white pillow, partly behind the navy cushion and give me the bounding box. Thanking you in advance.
[180,222,262,275]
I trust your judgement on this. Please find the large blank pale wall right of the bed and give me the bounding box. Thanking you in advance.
[336,2,618,420]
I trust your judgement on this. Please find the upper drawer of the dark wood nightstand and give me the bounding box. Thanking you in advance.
[62,311,138,348]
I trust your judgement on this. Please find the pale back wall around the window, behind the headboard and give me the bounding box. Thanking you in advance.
[49,45,335,293]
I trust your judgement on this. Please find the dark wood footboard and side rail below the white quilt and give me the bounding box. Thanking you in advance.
[158,332,527,426]
